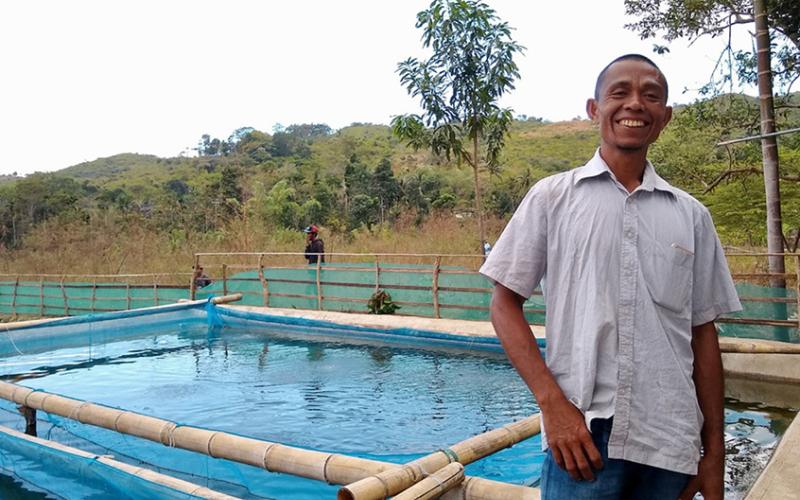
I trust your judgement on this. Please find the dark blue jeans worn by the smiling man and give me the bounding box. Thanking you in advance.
[541,419,691,500]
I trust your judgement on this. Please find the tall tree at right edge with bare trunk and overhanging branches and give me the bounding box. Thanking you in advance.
[625,0,800,287]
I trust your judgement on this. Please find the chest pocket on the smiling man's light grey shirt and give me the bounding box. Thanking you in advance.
[639,241,694,313]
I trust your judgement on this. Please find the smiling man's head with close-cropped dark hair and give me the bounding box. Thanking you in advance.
[586,60,672,152]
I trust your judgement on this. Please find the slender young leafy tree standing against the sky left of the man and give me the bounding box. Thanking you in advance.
[392,0,524,252]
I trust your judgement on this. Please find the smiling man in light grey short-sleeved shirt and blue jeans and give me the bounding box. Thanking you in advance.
[481,54,741,500]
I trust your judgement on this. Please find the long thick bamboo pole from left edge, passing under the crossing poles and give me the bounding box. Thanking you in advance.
[0,381,536,500]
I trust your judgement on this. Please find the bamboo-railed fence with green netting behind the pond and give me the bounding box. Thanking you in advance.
[0,252,800,334]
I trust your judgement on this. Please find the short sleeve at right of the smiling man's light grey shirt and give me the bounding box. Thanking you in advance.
[692,207,742,326]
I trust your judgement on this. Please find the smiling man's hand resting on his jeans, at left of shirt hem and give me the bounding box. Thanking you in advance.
[539,395,603,481]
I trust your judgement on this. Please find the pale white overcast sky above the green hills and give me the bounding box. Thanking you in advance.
[0,0,750,175]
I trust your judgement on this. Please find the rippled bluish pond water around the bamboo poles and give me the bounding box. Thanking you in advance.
[0,323,794,499]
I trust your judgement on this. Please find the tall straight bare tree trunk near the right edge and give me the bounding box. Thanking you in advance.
[753,0,786,288]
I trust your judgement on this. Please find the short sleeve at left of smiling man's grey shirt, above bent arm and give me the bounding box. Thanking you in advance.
[480,180,547,299]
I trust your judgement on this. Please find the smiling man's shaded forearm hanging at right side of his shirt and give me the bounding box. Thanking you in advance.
[692,322,725,458]
